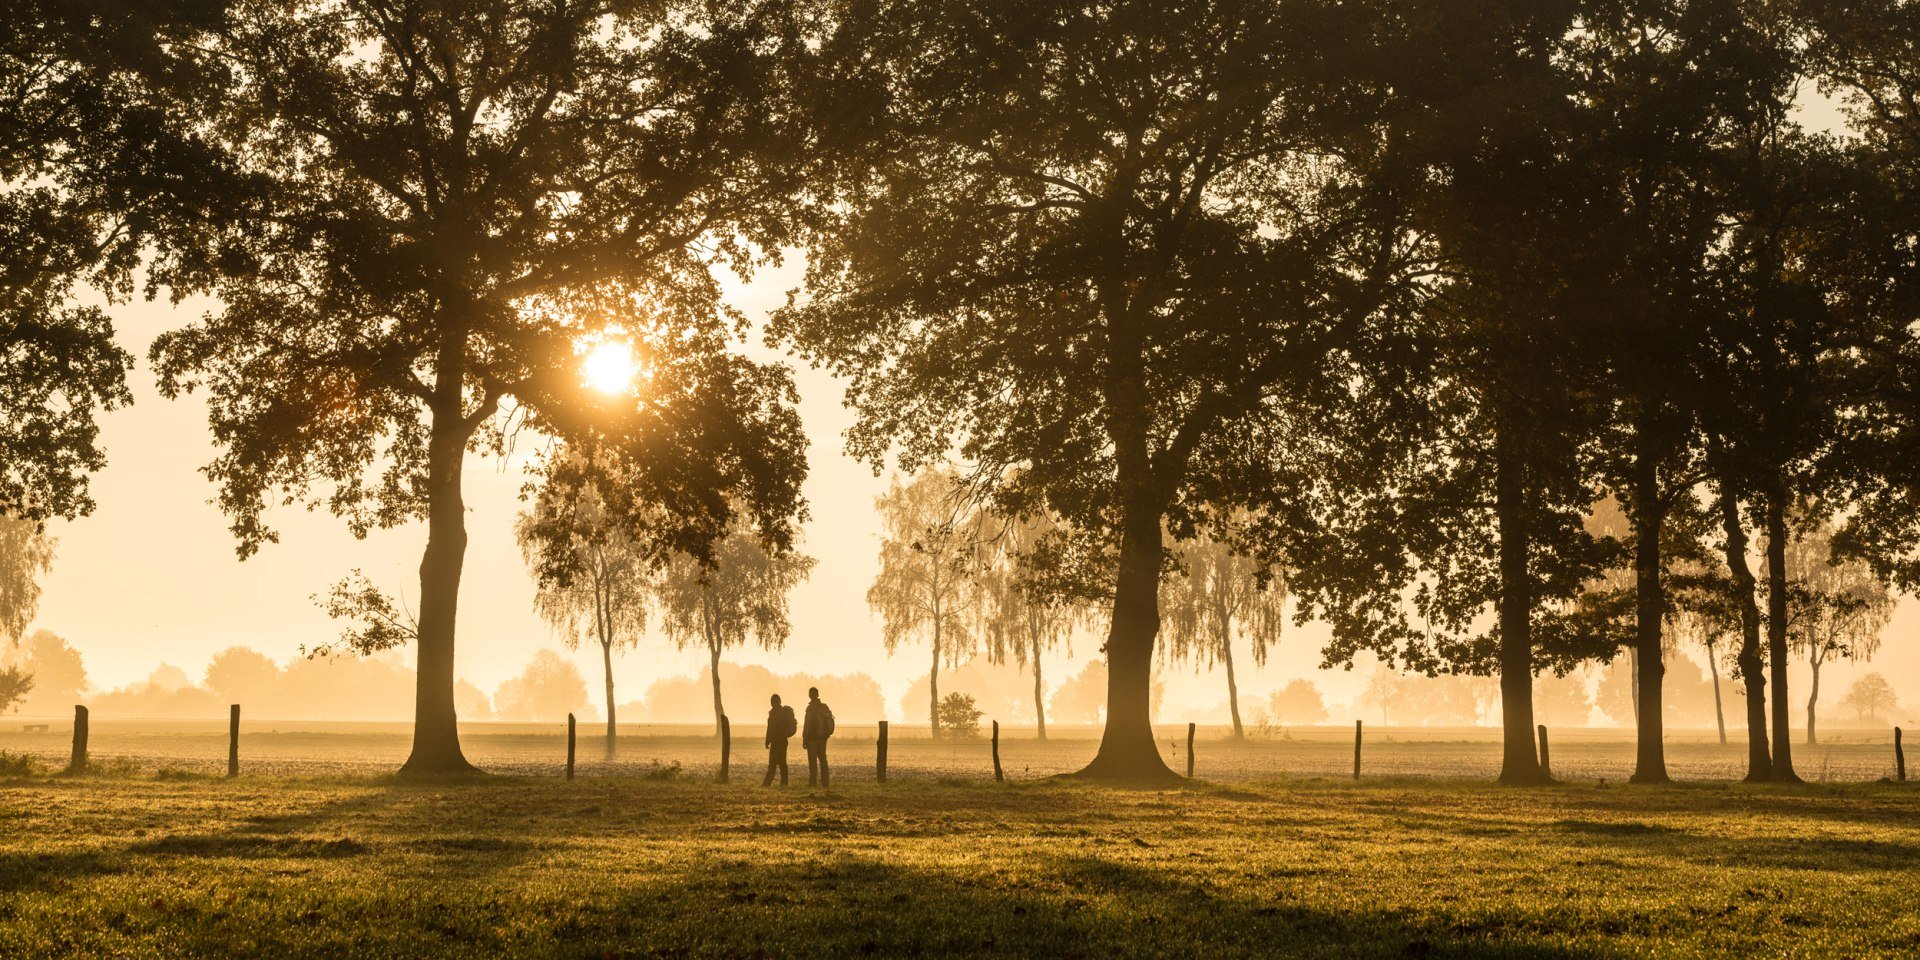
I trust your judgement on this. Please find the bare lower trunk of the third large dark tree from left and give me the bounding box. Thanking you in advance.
[1494,428,1551,783]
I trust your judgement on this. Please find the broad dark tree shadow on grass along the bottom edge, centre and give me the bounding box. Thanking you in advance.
[583,854,1597,960]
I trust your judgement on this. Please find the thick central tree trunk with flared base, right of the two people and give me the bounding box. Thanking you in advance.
[1081,497,1179,783]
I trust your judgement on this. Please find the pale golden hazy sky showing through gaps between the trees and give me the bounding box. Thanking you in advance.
[35,84,1920,716]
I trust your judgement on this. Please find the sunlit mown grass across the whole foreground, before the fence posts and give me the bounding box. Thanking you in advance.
[0,776,1920,958]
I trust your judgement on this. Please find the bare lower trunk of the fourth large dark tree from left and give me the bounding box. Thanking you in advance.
[1632,436,1670,783]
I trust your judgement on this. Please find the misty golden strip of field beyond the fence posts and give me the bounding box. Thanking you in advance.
[0,716,1895,783]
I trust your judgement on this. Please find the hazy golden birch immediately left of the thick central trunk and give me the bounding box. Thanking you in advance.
[977,513,1087,739]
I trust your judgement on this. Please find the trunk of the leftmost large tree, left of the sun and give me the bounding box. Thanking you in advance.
[399,408,474,774]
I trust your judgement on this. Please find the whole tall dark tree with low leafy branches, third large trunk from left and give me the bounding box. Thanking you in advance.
[1277,0,1609,783]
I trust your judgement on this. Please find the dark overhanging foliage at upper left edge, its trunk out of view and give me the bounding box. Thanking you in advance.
[0,0,192,526]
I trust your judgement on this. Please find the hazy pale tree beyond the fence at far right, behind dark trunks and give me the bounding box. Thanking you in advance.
[1784,522,1893,743]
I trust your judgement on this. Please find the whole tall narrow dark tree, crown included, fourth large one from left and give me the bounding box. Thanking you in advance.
[1569,0,1793,783]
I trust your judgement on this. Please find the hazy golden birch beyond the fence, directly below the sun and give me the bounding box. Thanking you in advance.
[513,453,651,755]
